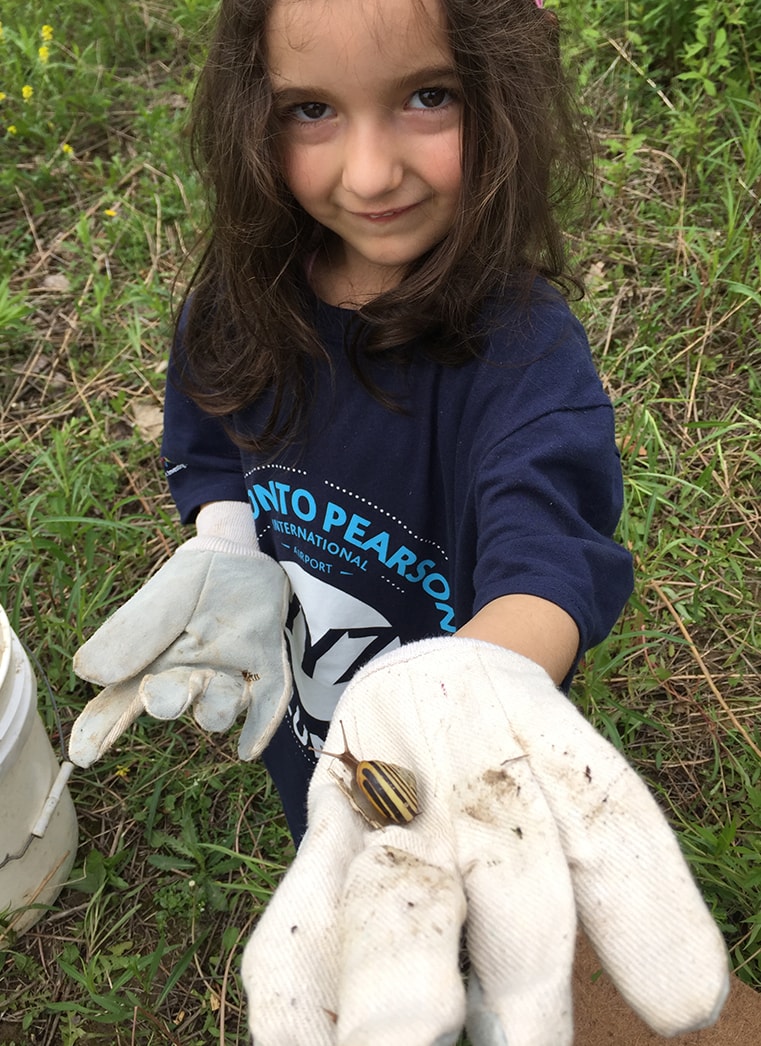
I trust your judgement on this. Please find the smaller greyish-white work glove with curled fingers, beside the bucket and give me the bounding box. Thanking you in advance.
[69,501,291,767]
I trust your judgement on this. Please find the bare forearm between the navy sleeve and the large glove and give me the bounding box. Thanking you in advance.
[457,593,579,686]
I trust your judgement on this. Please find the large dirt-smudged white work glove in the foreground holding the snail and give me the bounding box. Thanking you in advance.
[243,637,729,1046]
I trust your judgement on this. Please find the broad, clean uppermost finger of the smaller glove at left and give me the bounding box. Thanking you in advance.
[74,548,213,686]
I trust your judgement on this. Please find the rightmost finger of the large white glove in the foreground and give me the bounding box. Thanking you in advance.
[516,695,729,1037]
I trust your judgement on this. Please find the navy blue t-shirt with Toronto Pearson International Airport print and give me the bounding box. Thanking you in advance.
[163,285,632,838]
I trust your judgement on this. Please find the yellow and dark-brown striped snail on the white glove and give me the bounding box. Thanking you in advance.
[321,721,420,828]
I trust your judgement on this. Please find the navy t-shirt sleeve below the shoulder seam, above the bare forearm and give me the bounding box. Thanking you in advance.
[475,406,632,653]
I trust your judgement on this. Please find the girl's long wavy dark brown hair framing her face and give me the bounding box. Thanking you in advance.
[176,0,589,450]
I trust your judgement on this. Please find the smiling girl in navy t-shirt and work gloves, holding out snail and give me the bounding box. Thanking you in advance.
[71,0,727,1046]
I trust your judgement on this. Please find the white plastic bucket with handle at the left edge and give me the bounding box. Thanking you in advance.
[0,606,77,945]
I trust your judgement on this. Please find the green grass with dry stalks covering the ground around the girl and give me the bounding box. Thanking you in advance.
[0,0,761,1046]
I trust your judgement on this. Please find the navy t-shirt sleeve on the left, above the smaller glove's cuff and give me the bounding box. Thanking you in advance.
[161,336,248,523]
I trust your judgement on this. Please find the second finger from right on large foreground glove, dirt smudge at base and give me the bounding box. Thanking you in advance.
[456,758,576,1046]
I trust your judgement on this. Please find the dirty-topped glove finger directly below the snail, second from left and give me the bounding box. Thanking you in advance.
[337,822,465,1046]
